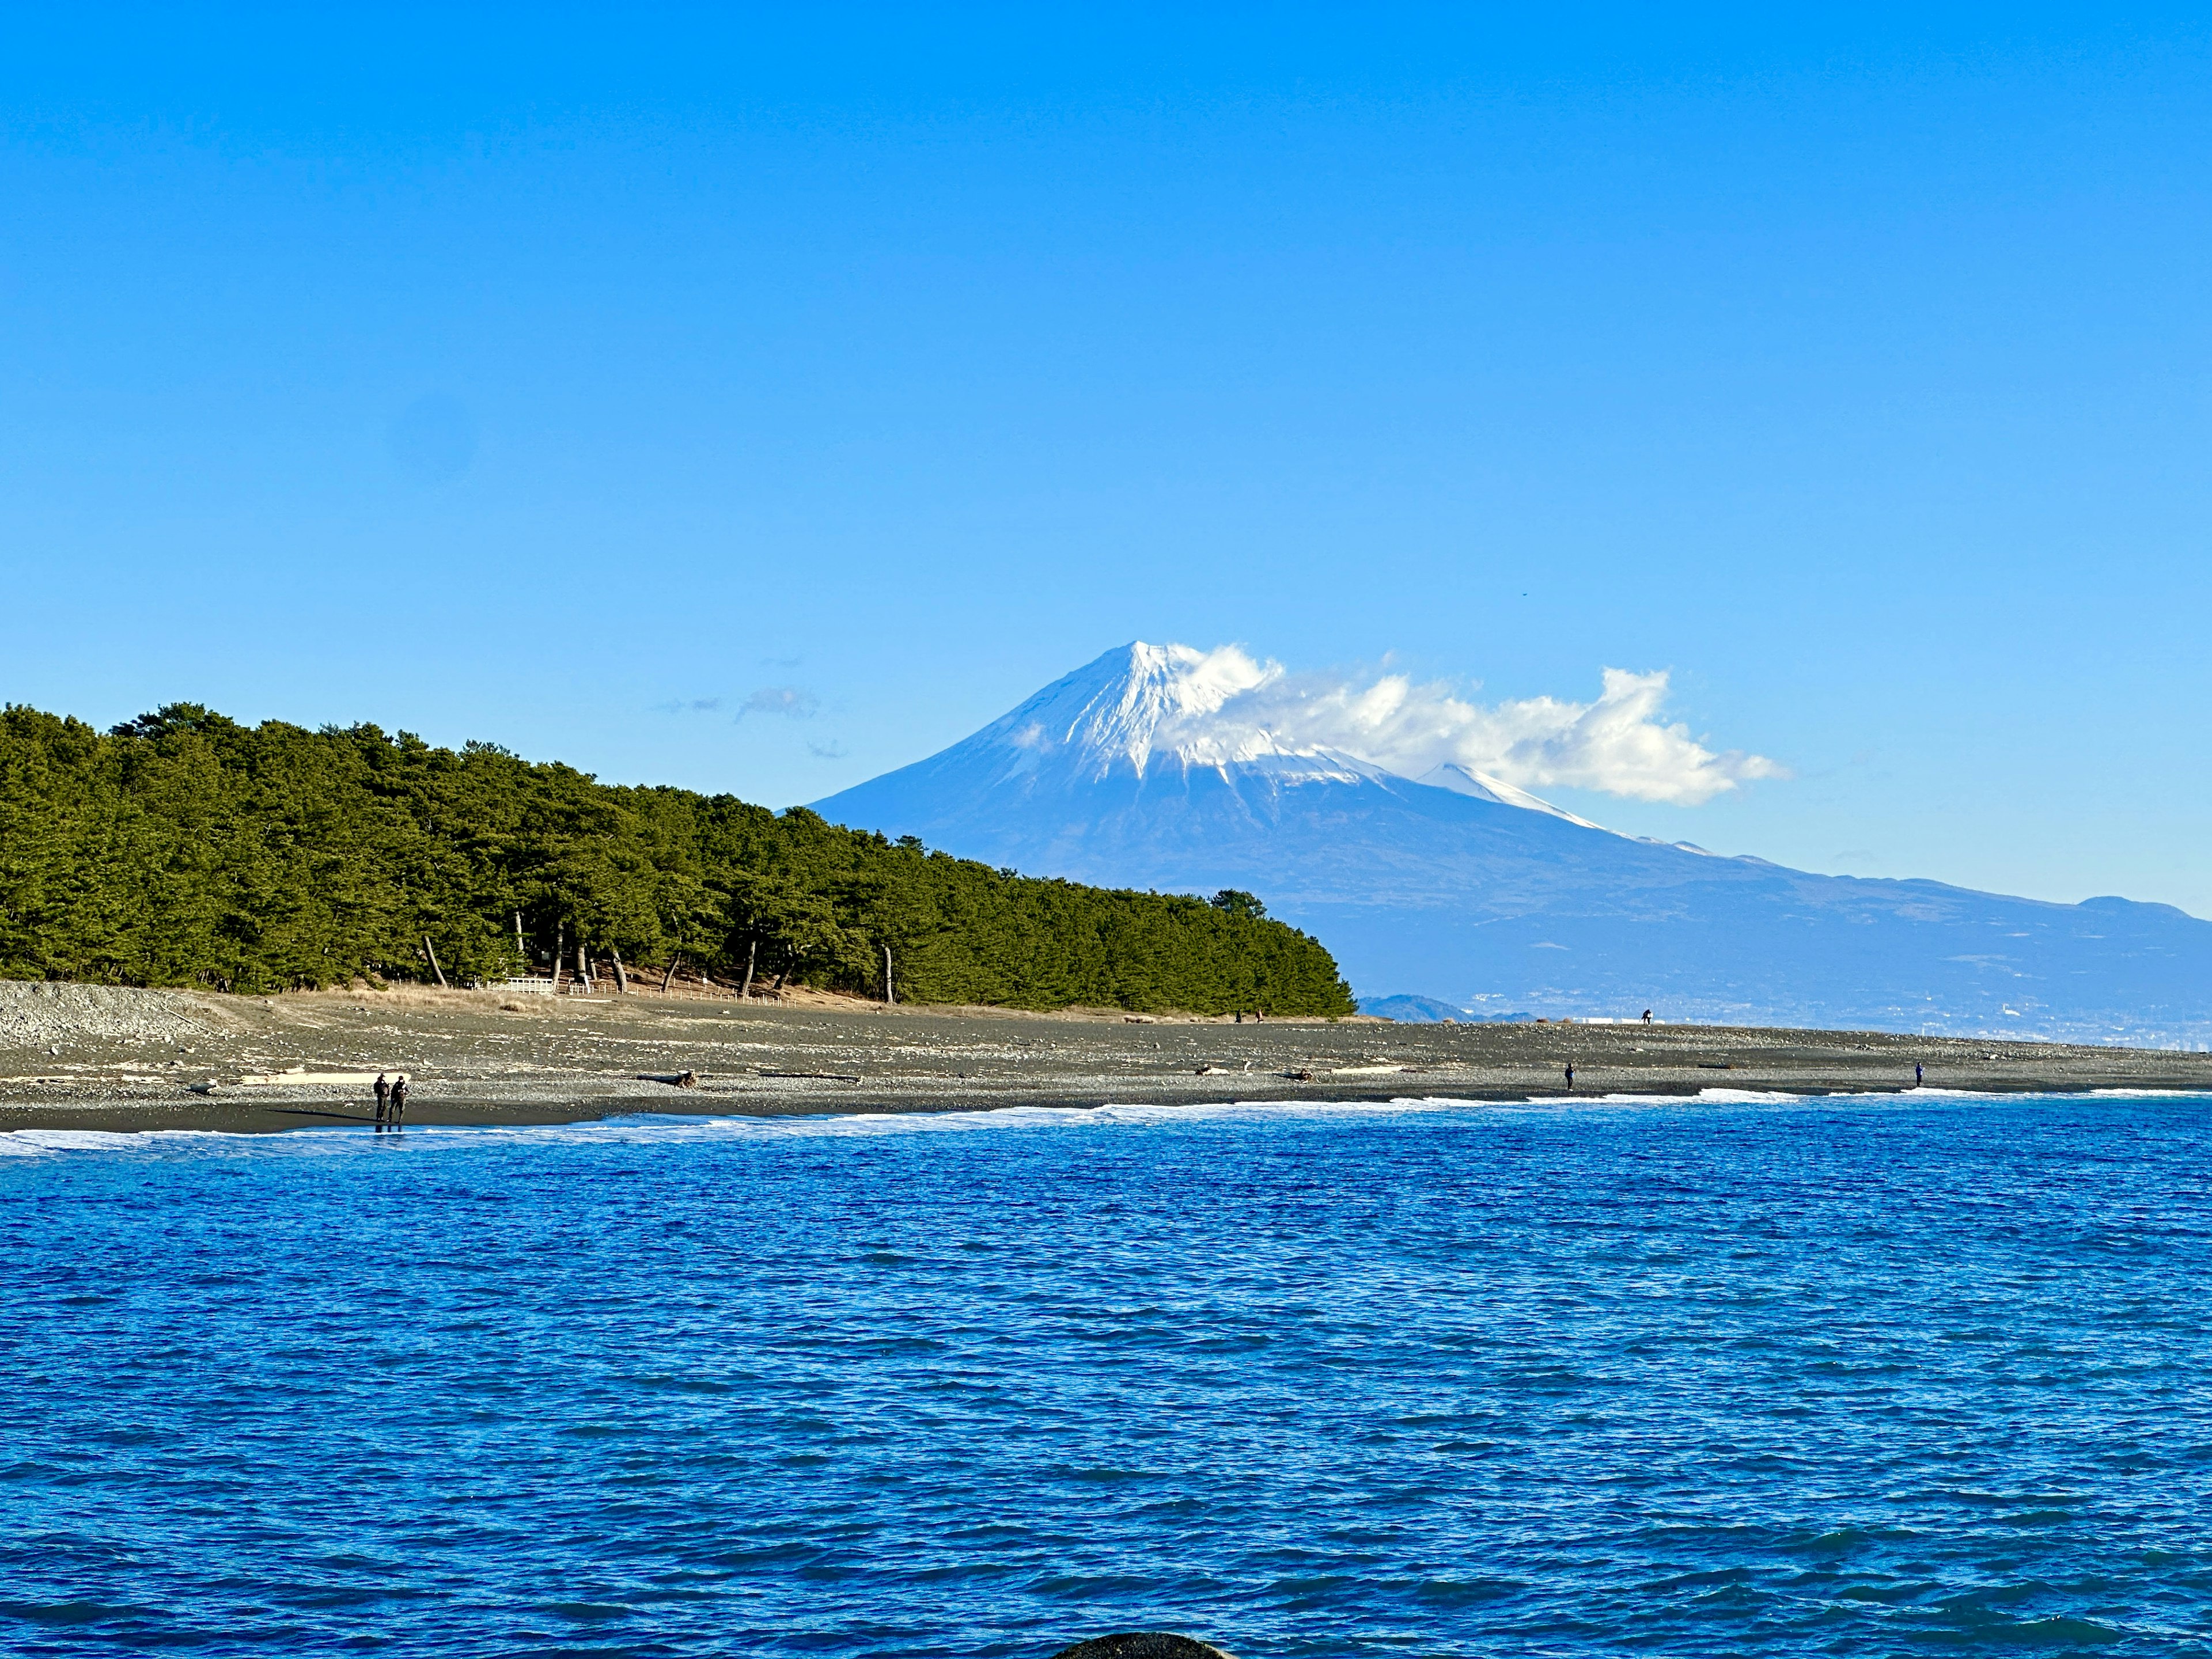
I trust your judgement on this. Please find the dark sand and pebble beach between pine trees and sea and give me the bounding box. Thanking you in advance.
[0,982,2212,1130]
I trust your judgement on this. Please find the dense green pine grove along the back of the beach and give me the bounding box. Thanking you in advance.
[0,703,1354,1016]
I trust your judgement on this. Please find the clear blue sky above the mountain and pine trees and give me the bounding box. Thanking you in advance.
[0,7,2212,916]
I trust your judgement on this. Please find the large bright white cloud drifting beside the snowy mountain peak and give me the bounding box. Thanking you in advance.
[1154,646,1787,805]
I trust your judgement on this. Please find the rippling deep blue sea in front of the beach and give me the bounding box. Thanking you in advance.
[0,1097,2212,1659]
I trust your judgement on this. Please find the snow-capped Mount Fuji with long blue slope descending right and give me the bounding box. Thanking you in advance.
[814,643,2212,1044]
